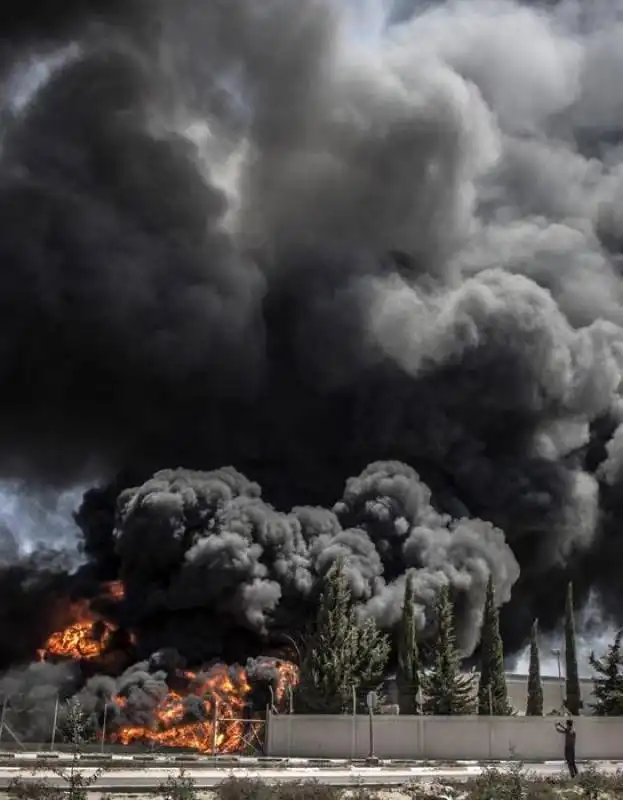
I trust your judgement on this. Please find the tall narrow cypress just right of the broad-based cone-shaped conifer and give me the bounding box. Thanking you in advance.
[478,577,511,716]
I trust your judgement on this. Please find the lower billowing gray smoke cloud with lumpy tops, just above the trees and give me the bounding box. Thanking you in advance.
[114,462,519,662]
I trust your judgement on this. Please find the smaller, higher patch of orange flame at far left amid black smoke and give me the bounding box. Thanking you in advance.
[38,581,123,661]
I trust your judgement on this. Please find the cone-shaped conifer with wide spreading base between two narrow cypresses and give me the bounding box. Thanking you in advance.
[424,586,474,716]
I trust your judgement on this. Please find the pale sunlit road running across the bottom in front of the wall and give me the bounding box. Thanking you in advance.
[0,762,621,793]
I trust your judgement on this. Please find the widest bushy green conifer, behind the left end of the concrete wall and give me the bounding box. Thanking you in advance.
[297,562,389,714]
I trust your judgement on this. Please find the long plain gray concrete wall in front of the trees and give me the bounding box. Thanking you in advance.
[266,714,623,761]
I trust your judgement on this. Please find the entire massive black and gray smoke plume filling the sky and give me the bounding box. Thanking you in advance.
[0,0,623,692]
